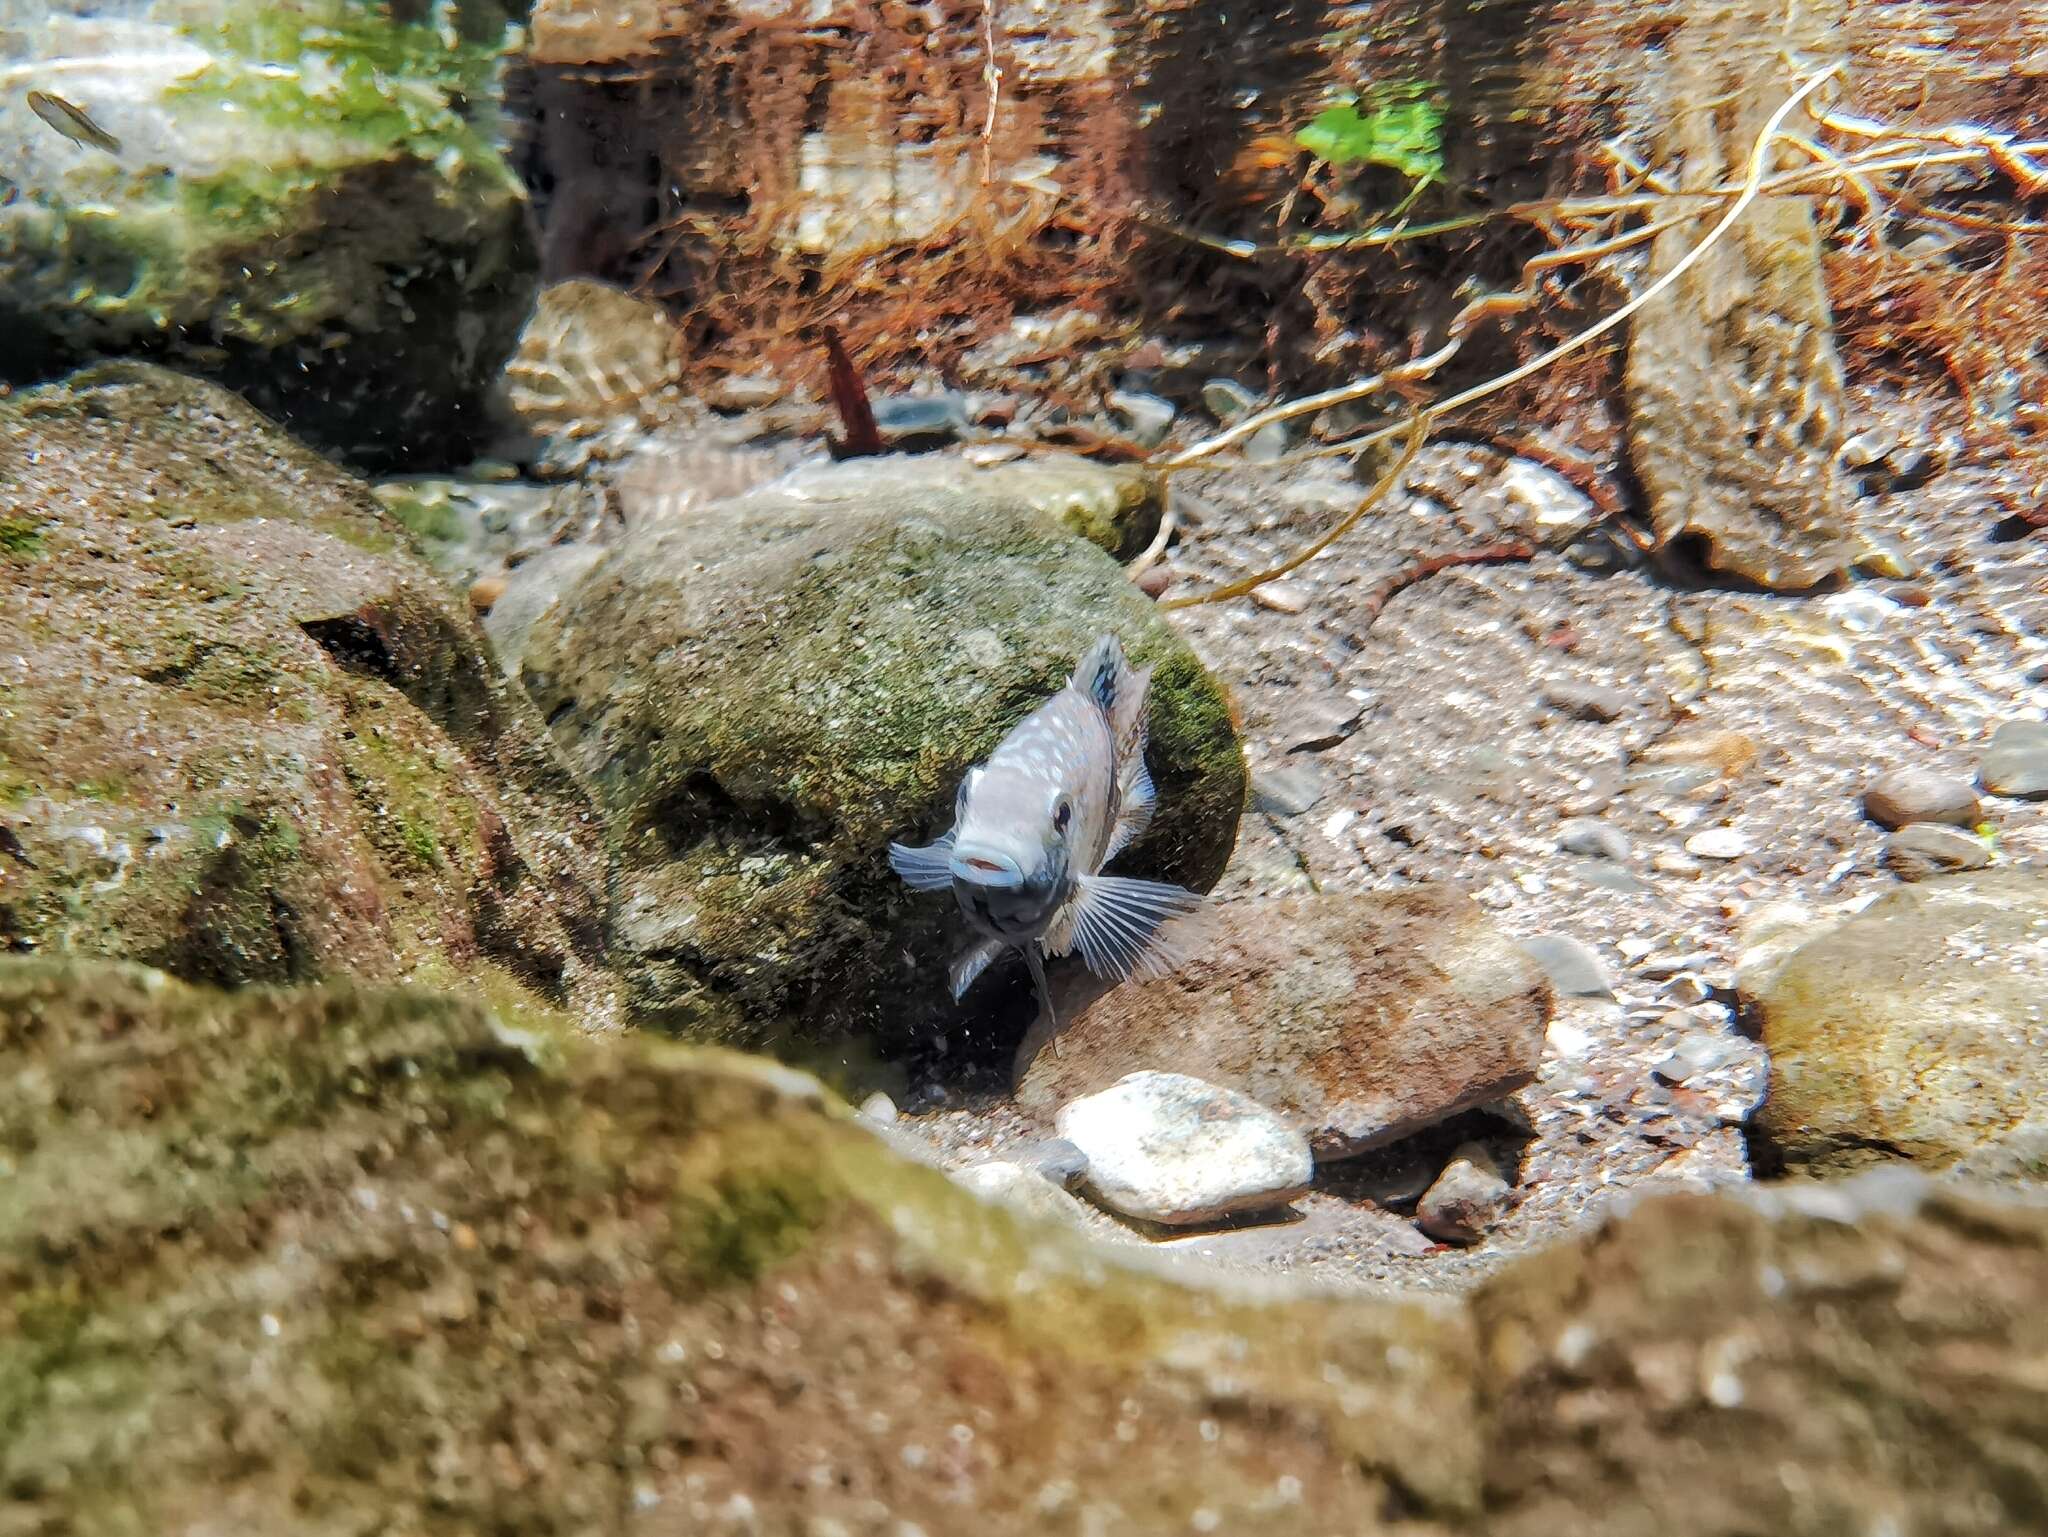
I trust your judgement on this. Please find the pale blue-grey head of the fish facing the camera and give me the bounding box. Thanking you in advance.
[950,762,1075,941]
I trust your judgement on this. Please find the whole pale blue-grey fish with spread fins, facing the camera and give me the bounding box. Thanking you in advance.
[889,635,1202,1041]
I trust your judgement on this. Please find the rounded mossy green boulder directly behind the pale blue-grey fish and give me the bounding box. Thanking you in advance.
[522,467,1245,1049]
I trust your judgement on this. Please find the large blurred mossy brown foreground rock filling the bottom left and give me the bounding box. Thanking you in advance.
[0,959,1477,1537]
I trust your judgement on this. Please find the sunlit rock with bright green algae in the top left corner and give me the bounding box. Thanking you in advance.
[0,0,535,467]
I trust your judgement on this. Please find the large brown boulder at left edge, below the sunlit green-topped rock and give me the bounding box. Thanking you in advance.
[0,363,606,1016]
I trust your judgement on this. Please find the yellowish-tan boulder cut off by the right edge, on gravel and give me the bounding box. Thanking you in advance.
[1741,869,2048,1172]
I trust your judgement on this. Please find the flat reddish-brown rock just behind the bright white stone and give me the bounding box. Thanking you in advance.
[1018,887,1550,1158]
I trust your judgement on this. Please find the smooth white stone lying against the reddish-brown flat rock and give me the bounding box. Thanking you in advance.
[1057,1072,1315,1223]
